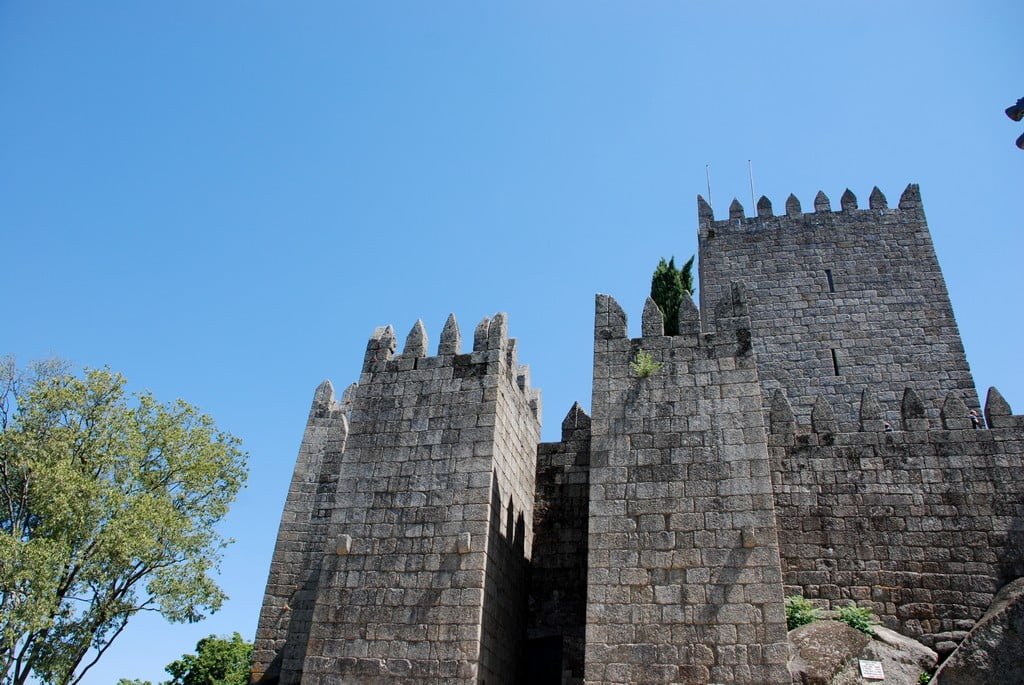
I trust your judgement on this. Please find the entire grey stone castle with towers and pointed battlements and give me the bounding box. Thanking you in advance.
[252,184,1024,685]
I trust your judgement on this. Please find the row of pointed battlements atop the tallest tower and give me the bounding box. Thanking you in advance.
[697,183,924,239]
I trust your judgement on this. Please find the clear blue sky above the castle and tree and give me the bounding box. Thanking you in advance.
[0,0,1024,685]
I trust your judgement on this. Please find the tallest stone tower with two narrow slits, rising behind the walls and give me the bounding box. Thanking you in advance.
[698,185,978,422]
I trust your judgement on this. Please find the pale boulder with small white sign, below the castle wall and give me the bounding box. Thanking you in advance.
[788,620,938,685]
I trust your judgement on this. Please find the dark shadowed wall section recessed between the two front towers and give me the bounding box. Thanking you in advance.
[525,403,591,685]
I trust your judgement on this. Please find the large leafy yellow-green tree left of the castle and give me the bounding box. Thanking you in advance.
[0,358,246,685]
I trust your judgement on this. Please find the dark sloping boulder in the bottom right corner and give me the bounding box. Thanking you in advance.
[932,579,1024,685]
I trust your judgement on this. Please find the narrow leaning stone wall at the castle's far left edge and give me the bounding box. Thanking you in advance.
[251,381,348,683]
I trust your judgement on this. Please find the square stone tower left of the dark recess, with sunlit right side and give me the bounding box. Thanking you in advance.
[302,314,539,685]
